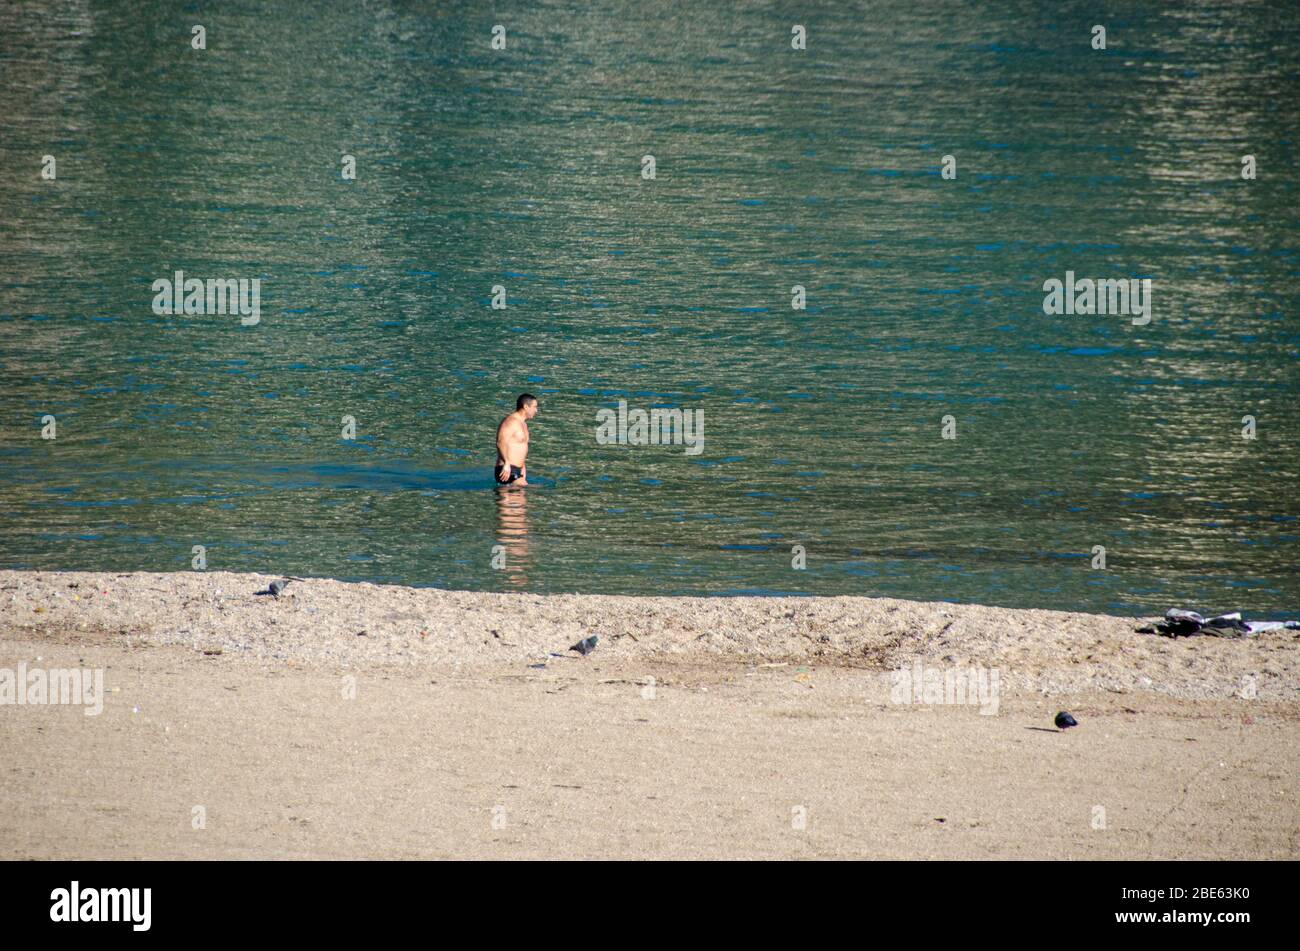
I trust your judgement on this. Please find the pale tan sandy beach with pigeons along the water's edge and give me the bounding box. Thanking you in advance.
[0,572,1300,859]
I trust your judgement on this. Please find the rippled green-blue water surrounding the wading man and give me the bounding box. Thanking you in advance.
[0,0,1300,617]
